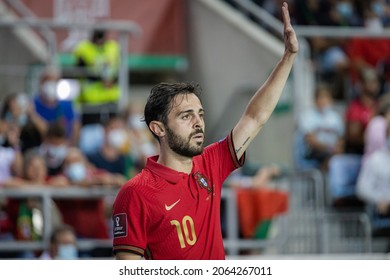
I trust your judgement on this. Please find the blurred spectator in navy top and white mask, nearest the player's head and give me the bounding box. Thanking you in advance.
[87,117,135,181]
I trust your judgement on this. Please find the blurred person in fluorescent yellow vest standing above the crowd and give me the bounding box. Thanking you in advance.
[74,30,120,124]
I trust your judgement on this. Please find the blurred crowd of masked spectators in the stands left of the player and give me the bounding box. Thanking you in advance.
[0,68,157,258]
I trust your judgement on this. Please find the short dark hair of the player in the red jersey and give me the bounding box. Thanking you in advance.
[144,83,202,139]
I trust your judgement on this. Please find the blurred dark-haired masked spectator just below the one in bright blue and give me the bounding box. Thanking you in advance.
[37,122,69,176]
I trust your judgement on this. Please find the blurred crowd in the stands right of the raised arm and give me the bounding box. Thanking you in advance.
[227,0,390,235]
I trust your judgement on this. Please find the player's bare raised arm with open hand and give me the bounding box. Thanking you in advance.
[233,2,299,158]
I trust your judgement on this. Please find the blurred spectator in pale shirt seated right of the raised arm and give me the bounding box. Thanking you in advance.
[298,84,344,170]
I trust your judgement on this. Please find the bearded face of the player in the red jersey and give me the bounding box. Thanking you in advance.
[166,94,204,157]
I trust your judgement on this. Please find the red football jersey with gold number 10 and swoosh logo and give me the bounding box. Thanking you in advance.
[113,134,245,260]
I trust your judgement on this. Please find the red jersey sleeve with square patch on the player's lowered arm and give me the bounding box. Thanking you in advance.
[112,185,149,256]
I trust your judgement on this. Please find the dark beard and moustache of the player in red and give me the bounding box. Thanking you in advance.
[166,126,204,157]
